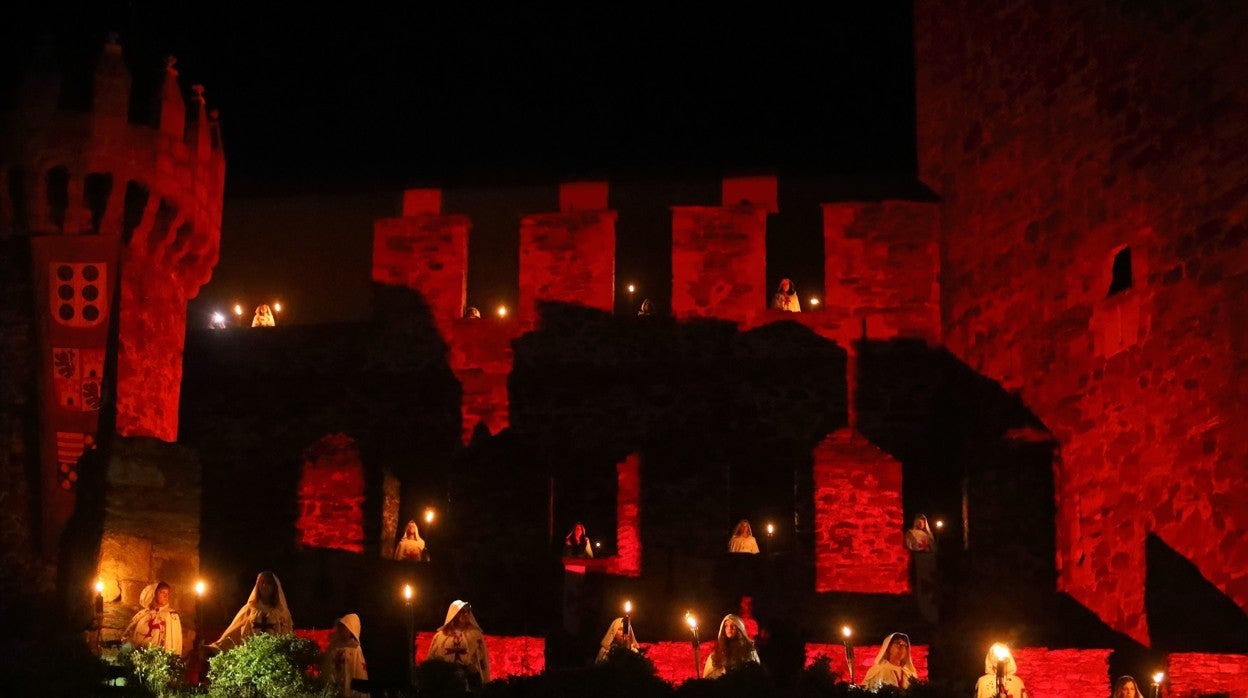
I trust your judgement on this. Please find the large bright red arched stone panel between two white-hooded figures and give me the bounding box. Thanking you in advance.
[814,430,910,594]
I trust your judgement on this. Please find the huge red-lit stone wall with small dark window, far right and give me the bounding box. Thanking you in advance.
[915,1,1248,643]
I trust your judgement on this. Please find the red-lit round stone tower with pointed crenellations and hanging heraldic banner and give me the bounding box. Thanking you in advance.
[0,37,225,551]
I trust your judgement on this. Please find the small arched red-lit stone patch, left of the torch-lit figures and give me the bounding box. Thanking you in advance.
[295,433,364,553]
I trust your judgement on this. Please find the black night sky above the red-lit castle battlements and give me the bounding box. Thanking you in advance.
[0,1,915,325]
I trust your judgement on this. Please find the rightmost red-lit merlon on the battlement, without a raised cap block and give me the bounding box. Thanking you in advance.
[820,201,940,346]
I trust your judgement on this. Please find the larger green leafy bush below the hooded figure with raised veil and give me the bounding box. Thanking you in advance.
[208,634,332,698]
